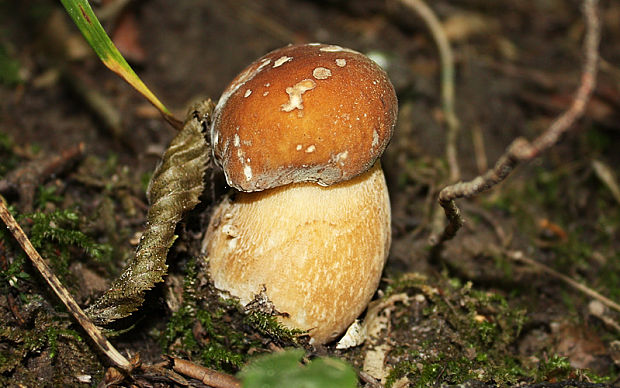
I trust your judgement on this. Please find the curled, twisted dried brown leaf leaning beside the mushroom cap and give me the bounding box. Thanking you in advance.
[87,100,213,325]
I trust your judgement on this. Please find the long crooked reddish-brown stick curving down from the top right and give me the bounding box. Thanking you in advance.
[429,0,601,249]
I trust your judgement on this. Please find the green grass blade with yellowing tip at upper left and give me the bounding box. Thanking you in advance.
[60,0,182,129]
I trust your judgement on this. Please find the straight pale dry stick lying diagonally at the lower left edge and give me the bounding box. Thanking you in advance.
[0,198,133,372]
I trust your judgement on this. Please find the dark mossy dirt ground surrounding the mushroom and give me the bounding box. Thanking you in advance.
[0,0,620,387]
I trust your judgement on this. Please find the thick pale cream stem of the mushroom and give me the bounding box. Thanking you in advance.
[205,163,390,343]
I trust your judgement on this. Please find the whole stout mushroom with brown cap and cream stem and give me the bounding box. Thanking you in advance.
[203,43,397,344]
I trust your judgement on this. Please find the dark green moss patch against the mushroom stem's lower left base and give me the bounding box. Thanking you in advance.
[159,255,312,373]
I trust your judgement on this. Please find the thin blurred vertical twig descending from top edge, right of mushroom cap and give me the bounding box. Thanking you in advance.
[400,0,461,182]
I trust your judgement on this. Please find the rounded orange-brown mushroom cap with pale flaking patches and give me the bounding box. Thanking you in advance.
[211,43,398,191]
